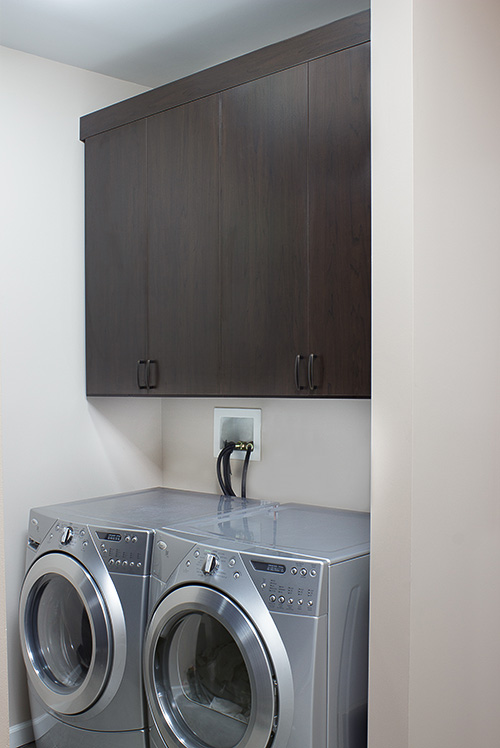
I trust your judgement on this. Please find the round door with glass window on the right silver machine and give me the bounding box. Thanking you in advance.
[144,585,278,748]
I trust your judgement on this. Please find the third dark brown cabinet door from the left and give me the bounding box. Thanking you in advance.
[221,65,307,396]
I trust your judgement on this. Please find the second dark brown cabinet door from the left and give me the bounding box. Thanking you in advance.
[148,95,219,395]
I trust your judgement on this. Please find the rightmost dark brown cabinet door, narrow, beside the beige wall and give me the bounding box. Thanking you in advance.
[309,44,371,397]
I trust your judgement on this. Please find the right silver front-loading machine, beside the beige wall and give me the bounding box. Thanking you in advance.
[143,504,370,748]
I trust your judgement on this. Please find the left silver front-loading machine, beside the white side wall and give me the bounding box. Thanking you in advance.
[20,488,260,748]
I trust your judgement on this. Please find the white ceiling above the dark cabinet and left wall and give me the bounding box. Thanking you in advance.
[0,0,370,87]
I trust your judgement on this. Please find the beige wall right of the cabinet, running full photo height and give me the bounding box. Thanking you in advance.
[370,0,500,748]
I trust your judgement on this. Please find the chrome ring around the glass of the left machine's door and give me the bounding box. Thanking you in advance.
[19,552,113,715]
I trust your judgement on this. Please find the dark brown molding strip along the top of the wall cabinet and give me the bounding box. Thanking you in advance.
[80,10,370,140]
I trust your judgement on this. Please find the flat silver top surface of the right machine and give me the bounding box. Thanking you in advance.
[173,503,370,561]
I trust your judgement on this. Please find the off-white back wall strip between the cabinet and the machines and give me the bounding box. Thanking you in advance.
[163,398,370,511]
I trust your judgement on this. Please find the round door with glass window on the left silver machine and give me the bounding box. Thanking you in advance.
[19,553,113,714]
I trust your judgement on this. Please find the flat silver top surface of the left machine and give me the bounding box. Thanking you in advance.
[36,487,263,529]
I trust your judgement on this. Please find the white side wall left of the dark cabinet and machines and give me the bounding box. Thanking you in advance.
[0,48,162,740]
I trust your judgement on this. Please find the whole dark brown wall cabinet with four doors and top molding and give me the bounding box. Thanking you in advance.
[81,13,370,397]
